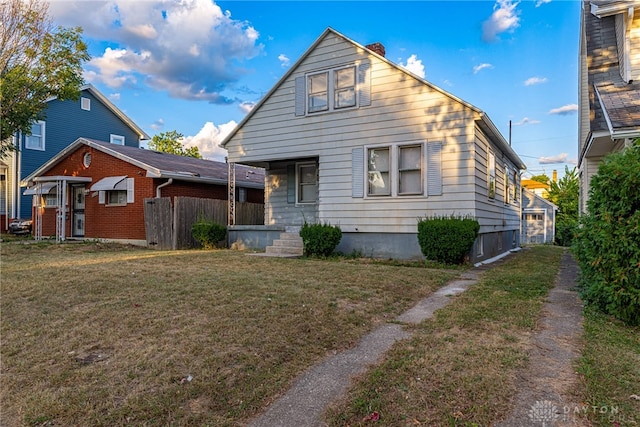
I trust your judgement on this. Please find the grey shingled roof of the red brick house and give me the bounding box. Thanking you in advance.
[21,138,264,188]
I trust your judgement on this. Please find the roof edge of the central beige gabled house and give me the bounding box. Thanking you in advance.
[220,27,526,169]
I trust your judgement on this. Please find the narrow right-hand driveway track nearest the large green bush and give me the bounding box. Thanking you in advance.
[497,252,589,427]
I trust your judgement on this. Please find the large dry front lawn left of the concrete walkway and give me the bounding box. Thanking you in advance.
[0,243,457,426]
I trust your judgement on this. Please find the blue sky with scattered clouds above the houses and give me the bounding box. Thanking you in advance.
[49,0,580,176]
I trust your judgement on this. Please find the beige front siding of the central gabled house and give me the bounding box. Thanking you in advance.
[227,34,482,233]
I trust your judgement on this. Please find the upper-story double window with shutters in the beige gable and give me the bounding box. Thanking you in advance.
[295,61,371,116]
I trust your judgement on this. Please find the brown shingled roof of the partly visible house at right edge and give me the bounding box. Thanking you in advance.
[581,0,640,141]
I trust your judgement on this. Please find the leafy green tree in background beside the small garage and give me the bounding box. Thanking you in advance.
[548,166,580,246]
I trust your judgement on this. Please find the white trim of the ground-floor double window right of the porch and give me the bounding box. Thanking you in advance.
[363,141,427,199]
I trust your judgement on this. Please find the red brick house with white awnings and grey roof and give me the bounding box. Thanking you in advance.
[24,138,264,244]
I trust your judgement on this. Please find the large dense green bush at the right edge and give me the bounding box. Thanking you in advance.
[572,145,640,325]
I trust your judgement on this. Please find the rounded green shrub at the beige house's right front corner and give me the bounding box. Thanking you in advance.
[418,215,480,264]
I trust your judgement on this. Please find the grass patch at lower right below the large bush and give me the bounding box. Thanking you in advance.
[578,310,640,426]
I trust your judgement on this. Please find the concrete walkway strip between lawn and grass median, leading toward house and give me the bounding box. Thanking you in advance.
[249,267,486,427]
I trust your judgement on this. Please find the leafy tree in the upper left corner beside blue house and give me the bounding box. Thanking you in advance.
[0,0,90,157]
